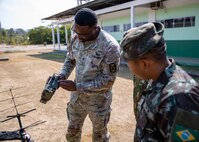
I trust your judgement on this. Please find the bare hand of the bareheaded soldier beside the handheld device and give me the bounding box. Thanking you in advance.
[58,80,77,91]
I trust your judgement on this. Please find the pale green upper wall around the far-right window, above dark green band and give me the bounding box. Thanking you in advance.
[156,4,199,40]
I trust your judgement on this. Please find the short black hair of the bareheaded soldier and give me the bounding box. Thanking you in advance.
[75,8,97,27]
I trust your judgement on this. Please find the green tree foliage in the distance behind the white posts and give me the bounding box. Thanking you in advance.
[0,25,70,45]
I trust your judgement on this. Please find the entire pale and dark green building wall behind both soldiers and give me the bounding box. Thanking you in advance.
[101,3,199,58]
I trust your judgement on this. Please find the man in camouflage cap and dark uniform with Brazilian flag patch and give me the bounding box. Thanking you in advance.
[121,23,199,142]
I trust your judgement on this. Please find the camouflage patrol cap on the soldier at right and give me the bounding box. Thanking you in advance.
[120,22,164,60]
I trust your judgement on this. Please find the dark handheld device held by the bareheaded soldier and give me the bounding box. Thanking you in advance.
[40,74,59,104]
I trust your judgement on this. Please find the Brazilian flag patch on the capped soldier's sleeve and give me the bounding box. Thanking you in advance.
[172,124,199,142]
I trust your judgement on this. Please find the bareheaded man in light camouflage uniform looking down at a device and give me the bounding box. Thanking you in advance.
[59,8,120,142]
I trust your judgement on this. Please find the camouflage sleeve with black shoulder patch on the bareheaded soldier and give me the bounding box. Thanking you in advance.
[76,46,120,93]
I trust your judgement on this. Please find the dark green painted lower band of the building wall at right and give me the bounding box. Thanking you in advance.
[166,40,199,58]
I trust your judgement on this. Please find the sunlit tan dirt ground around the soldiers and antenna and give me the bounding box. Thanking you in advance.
[0,49,135,142]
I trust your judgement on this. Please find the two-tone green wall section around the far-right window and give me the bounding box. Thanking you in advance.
[156,4,199,58]
